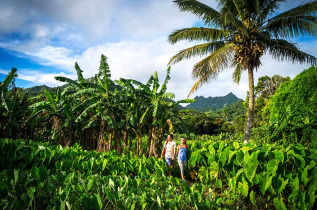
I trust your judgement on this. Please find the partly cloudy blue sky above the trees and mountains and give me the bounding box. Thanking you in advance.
[0,0,317,99]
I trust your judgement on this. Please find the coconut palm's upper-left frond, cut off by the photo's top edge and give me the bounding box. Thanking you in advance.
[173,0,221,27]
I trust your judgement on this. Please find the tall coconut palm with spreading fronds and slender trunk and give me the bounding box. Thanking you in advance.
[168,0,317,141]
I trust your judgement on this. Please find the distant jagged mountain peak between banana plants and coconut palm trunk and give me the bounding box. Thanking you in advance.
[185,92,241,112]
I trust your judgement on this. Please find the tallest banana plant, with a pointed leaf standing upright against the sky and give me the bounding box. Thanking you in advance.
[74,55,124,152]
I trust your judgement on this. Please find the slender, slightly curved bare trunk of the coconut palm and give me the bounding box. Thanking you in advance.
[243,66,254,143]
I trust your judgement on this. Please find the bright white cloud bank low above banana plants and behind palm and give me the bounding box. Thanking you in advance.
[11,37,308,100]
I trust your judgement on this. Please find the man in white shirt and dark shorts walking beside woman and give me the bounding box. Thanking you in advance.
[161,134,177,176]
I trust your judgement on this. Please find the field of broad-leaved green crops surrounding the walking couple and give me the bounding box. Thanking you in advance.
[0,139,317,209]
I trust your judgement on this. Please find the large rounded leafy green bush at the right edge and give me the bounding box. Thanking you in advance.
[270,67,317,148]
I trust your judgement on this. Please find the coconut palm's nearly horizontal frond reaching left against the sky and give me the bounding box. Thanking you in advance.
[168,27,227,44]
